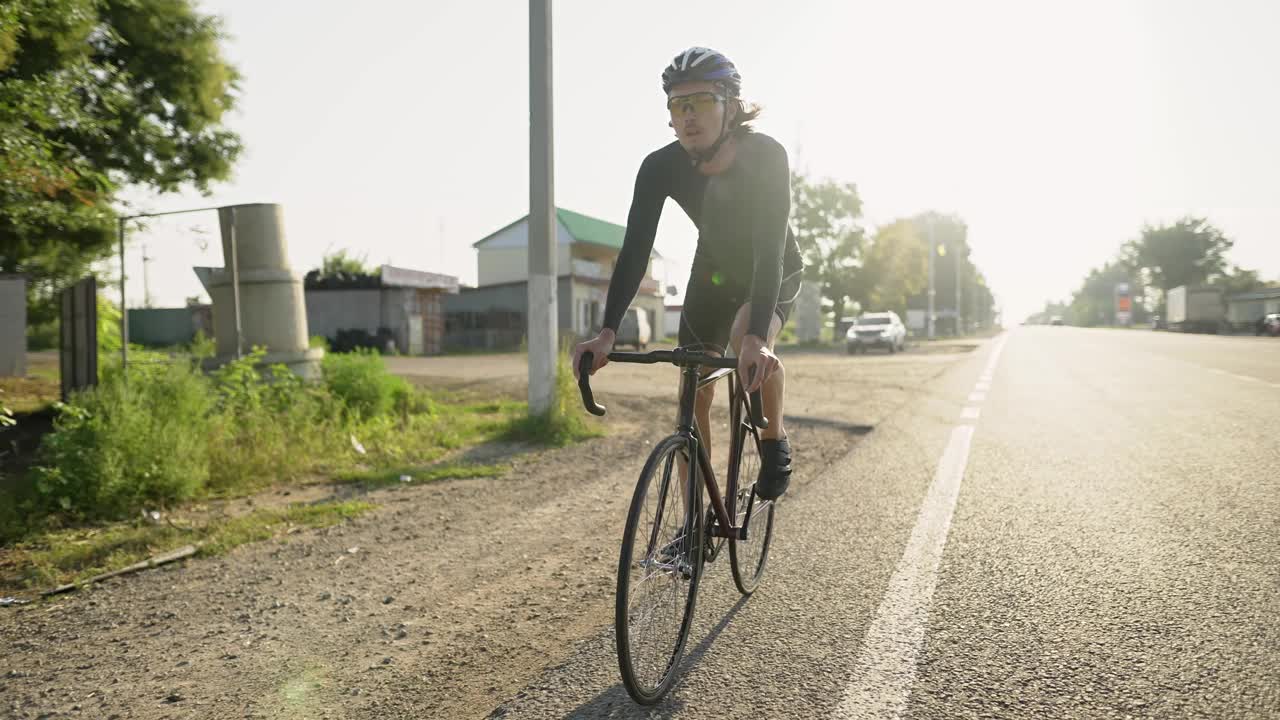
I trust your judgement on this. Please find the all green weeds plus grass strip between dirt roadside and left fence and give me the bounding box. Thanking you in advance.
[0,352,603,587]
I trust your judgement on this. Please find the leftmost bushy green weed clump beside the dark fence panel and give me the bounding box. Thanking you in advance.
[33,364,214,519]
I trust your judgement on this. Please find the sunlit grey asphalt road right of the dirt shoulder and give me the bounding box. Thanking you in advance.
[492,328,1280,719]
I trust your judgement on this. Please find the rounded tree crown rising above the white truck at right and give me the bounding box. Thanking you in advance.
[1123,218,1234,291]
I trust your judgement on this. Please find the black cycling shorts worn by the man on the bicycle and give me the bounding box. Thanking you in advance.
[680,260,804,355]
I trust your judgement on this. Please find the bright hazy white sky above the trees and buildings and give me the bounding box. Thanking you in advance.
[129,0,1280,322]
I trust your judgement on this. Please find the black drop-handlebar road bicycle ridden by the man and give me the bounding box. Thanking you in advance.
[579,347,776,705]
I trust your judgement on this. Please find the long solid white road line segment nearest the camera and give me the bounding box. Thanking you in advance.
[835,425,974,720]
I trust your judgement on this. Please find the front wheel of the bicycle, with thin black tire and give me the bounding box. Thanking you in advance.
[614,436,703,705]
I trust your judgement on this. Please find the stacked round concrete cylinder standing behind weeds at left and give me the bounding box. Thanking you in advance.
[201,204,324,379]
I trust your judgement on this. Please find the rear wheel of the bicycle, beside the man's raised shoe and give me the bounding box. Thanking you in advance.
[728,420,774,594]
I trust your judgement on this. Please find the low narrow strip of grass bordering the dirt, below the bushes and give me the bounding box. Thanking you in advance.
[0,501,375,594]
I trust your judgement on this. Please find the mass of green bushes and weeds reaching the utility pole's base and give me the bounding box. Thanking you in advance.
[13,338,599,532]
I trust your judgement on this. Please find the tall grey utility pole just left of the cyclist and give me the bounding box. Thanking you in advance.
[529,0,558,415]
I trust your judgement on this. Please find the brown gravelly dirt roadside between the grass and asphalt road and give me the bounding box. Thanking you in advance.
[0,346,970,720]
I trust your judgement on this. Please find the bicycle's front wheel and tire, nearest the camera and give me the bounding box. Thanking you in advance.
[613,434,704,705]
